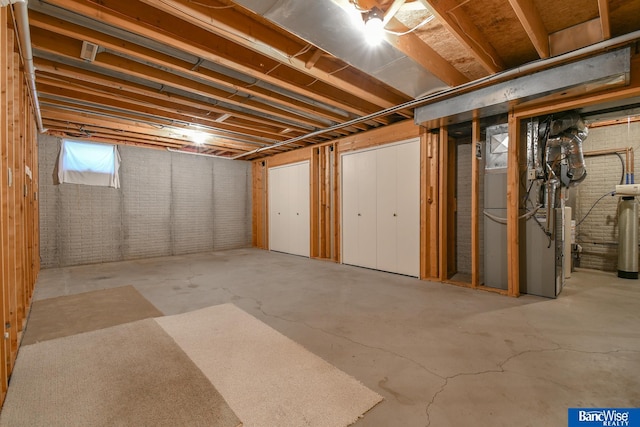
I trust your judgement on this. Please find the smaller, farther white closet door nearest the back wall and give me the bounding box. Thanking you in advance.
[268,162,311,257]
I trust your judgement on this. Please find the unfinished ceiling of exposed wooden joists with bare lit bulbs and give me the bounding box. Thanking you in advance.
[17,0,640,159]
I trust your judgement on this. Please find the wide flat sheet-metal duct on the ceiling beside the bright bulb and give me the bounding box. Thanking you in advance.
[235,0,449,98]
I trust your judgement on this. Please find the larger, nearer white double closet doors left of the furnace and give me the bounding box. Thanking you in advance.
[342,139,420,276]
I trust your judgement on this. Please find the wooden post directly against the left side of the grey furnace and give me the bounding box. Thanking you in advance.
[507,113,520,297]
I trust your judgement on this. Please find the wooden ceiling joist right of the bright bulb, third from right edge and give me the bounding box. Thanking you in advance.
[420,0,506,73]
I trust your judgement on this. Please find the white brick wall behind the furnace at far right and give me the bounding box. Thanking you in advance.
[574,123,640,271]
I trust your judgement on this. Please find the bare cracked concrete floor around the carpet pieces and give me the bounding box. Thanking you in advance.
[30,249,640,427]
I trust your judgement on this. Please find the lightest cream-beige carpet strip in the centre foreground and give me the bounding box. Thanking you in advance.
[156,304,382,427]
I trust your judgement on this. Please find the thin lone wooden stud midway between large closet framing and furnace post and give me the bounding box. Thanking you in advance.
[471,117,481,288]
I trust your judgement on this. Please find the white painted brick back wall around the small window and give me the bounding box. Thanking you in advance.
[38,136,251,268]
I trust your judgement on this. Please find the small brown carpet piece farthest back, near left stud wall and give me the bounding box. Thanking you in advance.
[22,286,163,345]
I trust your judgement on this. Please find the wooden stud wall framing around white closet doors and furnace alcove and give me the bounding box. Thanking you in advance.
[254,54,640,297]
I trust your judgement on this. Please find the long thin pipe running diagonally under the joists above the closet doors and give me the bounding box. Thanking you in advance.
[231,30,640,160]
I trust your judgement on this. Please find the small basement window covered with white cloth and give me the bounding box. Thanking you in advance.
[58,139,120,188]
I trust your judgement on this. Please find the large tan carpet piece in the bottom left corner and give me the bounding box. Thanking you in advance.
[0,319,242,427]
